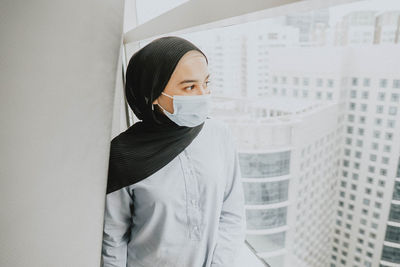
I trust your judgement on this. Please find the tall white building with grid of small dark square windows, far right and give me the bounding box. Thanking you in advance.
[260,45,400,266]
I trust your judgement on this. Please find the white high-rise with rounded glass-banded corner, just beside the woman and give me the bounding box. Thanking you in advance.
[213,97,340,267]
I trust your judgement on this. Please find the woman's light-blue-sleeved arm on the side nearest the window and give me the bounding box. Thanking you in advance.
[211,126,246,267]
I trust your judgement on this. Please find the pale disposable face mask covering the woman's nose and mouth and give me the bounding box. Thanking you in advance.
[157,92,211,127]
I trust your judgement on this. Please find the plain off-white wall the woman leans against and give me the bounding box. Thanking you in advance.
[0,0,124,267]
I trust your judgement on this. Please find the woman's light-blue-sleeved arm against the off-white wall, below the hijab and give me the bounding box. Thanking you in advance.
[101,187,133,267]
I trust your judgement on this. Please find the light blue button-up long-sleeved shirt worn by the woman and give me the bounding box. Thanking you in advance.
[102,118,246,267]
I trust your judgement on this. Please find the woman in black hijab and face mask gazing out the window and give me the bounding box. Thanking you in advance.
[102,36,246,267]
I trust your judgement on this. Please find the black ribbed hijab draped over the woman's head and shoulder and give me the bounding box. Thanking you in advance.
[107,36,208,194]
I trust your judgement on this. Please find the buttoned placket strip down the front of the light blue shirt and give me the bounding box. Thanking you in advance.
[180,150,202,240]
